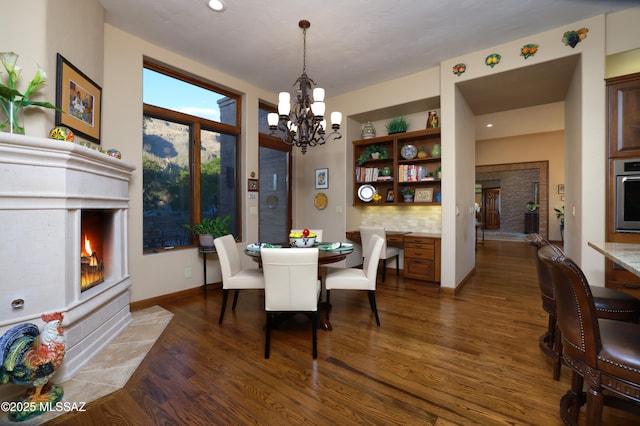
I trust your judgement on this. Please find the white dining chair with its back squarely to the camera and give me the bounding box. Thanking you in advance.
[260,248,321,359]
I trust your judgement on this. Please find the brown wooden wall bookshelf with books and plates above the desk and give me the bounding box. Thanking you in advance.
[353,128,442,206]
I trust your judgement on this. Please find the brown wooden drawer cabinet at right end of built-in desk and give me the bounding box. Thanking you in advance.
[403,233,440,283]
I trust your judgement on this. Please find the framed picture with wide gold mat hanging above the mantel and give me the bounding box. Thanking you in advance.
[56,53,102,144]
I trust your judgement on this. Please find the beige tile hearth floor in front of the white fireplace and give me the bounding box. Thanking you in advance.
[0,306,173,425]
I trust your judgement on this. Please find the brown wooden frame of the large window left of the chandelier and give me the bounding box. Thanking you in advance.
[142,58,243,250]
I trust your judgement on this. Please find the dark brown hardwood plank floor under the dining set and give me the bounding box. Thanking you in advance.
[47,241,640,425]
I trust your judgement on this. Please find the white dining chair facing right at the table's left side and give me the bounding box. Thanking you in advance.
[213,234,264,324]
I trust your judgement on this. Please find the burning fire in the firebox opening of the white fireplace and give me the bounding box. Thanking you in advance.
[80,210,110,291]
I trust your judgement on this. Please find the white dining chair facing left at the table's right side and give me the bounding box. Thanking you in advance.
[324,235,384,326]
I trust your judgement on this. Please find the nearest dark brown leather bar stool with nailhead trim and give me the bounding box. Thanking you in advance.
[538,245,640,426]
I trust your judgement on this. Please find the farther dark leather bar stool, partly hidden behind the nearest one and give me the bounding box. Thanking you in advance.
[525,234,640,380]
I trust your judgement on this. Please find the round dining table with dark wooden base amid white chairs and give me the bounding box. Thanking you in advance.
[244,242,353,331]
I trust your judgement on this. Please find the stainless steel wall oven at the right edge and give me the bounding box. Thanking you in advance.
[613,158,640,232]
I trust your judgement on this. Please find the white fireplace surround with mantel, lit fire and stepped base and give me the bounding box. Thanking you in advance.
[0,133,135,390]
